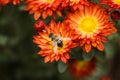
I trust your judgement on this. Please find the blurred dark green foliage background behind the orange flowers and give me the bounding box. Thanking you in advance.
[0,4,120,80]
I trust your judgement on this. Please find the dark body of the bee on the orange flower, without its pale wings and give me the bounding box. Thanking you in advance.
[49,33,63,47]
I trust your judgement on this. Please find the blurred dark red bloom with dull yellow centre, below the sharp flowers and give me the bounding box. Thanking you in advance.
[68,58,96,80]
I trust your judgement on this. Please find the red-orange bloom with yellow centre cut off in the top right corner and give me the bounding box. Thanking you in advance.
[100,0,120,10]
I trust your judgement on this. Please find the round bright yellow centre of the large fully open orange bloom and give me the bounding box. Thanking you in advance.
[79,17,98,34]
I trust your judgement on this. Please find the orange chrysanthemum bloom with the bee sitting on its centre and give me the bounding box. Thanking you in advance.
[33,21,75,63]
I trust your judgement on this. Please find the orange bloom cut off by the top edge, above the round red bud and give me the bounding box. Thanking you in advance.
[25,0,61,20]
